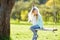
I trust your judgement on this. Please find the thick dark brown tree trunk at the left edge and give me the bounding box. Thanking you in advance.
[0,0,15,40]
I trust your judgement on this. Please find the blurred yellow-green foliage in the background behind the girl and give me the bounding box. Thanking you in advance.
[11,0,60,22]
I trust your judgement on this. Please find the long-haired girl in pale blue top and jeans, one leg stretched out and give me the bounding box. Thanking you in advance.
[28,6,57,40]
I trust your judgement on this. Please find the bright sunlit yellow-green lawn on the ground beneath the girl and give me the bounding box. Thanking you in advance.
[10,24,60,40]
